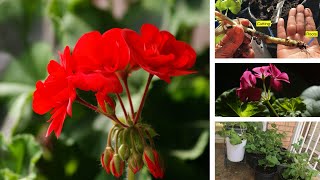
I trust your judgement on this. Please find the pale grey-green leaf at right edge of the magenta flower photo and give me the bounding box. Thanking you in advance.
[300,86,320,117]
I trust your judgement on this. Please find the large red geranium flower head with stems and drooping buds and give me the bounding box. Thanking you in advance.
[32,24,196,178]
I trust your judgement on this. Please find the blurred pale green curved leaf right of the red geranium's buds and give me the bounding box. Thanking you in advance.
[171,130,209,160]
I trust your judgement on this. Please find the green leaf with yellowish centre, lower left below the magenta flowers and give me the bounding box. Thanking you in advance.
[216,88,270,117]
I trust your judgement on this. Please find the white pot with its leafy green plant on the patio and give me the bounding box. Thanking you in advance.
[218,122,247,162]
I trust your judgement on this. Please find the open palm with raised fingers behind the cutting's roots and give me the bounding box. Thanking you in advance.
[277,5,320,58]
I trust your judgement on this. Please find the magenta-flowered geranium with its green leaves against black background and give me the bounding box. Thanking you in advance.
[216,64,306,117]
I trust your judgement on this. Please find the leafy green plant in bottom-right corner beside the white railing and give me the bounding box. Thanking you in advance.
[279,143,320,180]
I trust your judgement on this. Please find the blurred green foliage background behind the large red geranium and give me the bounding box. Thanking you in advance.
[0,0,209,180]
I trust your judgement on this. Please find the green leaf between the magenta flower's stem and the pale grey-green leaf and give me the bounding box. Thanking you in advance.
[272,97,306,117]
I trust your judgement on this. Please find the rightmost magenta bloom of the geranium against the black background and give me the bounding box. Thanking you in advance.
[270,64,290,91]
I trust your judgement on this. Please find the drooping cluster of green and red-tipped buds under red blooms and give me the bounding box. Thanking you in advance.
[101,123,164,178]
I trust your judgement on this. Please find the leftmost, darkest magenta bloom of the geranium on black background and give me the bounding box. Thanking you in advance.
[236,70,261,102]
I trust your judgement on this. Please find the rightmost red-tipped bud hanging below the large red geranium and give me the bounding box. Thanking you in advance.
[142,146,164,178]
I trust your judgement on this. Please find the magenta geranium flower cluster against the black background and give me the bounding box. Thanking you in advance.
[236,64,290,102]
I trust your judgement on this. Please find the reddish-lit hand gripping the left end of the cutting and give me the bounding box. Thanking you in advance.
[215,19,254,58]
